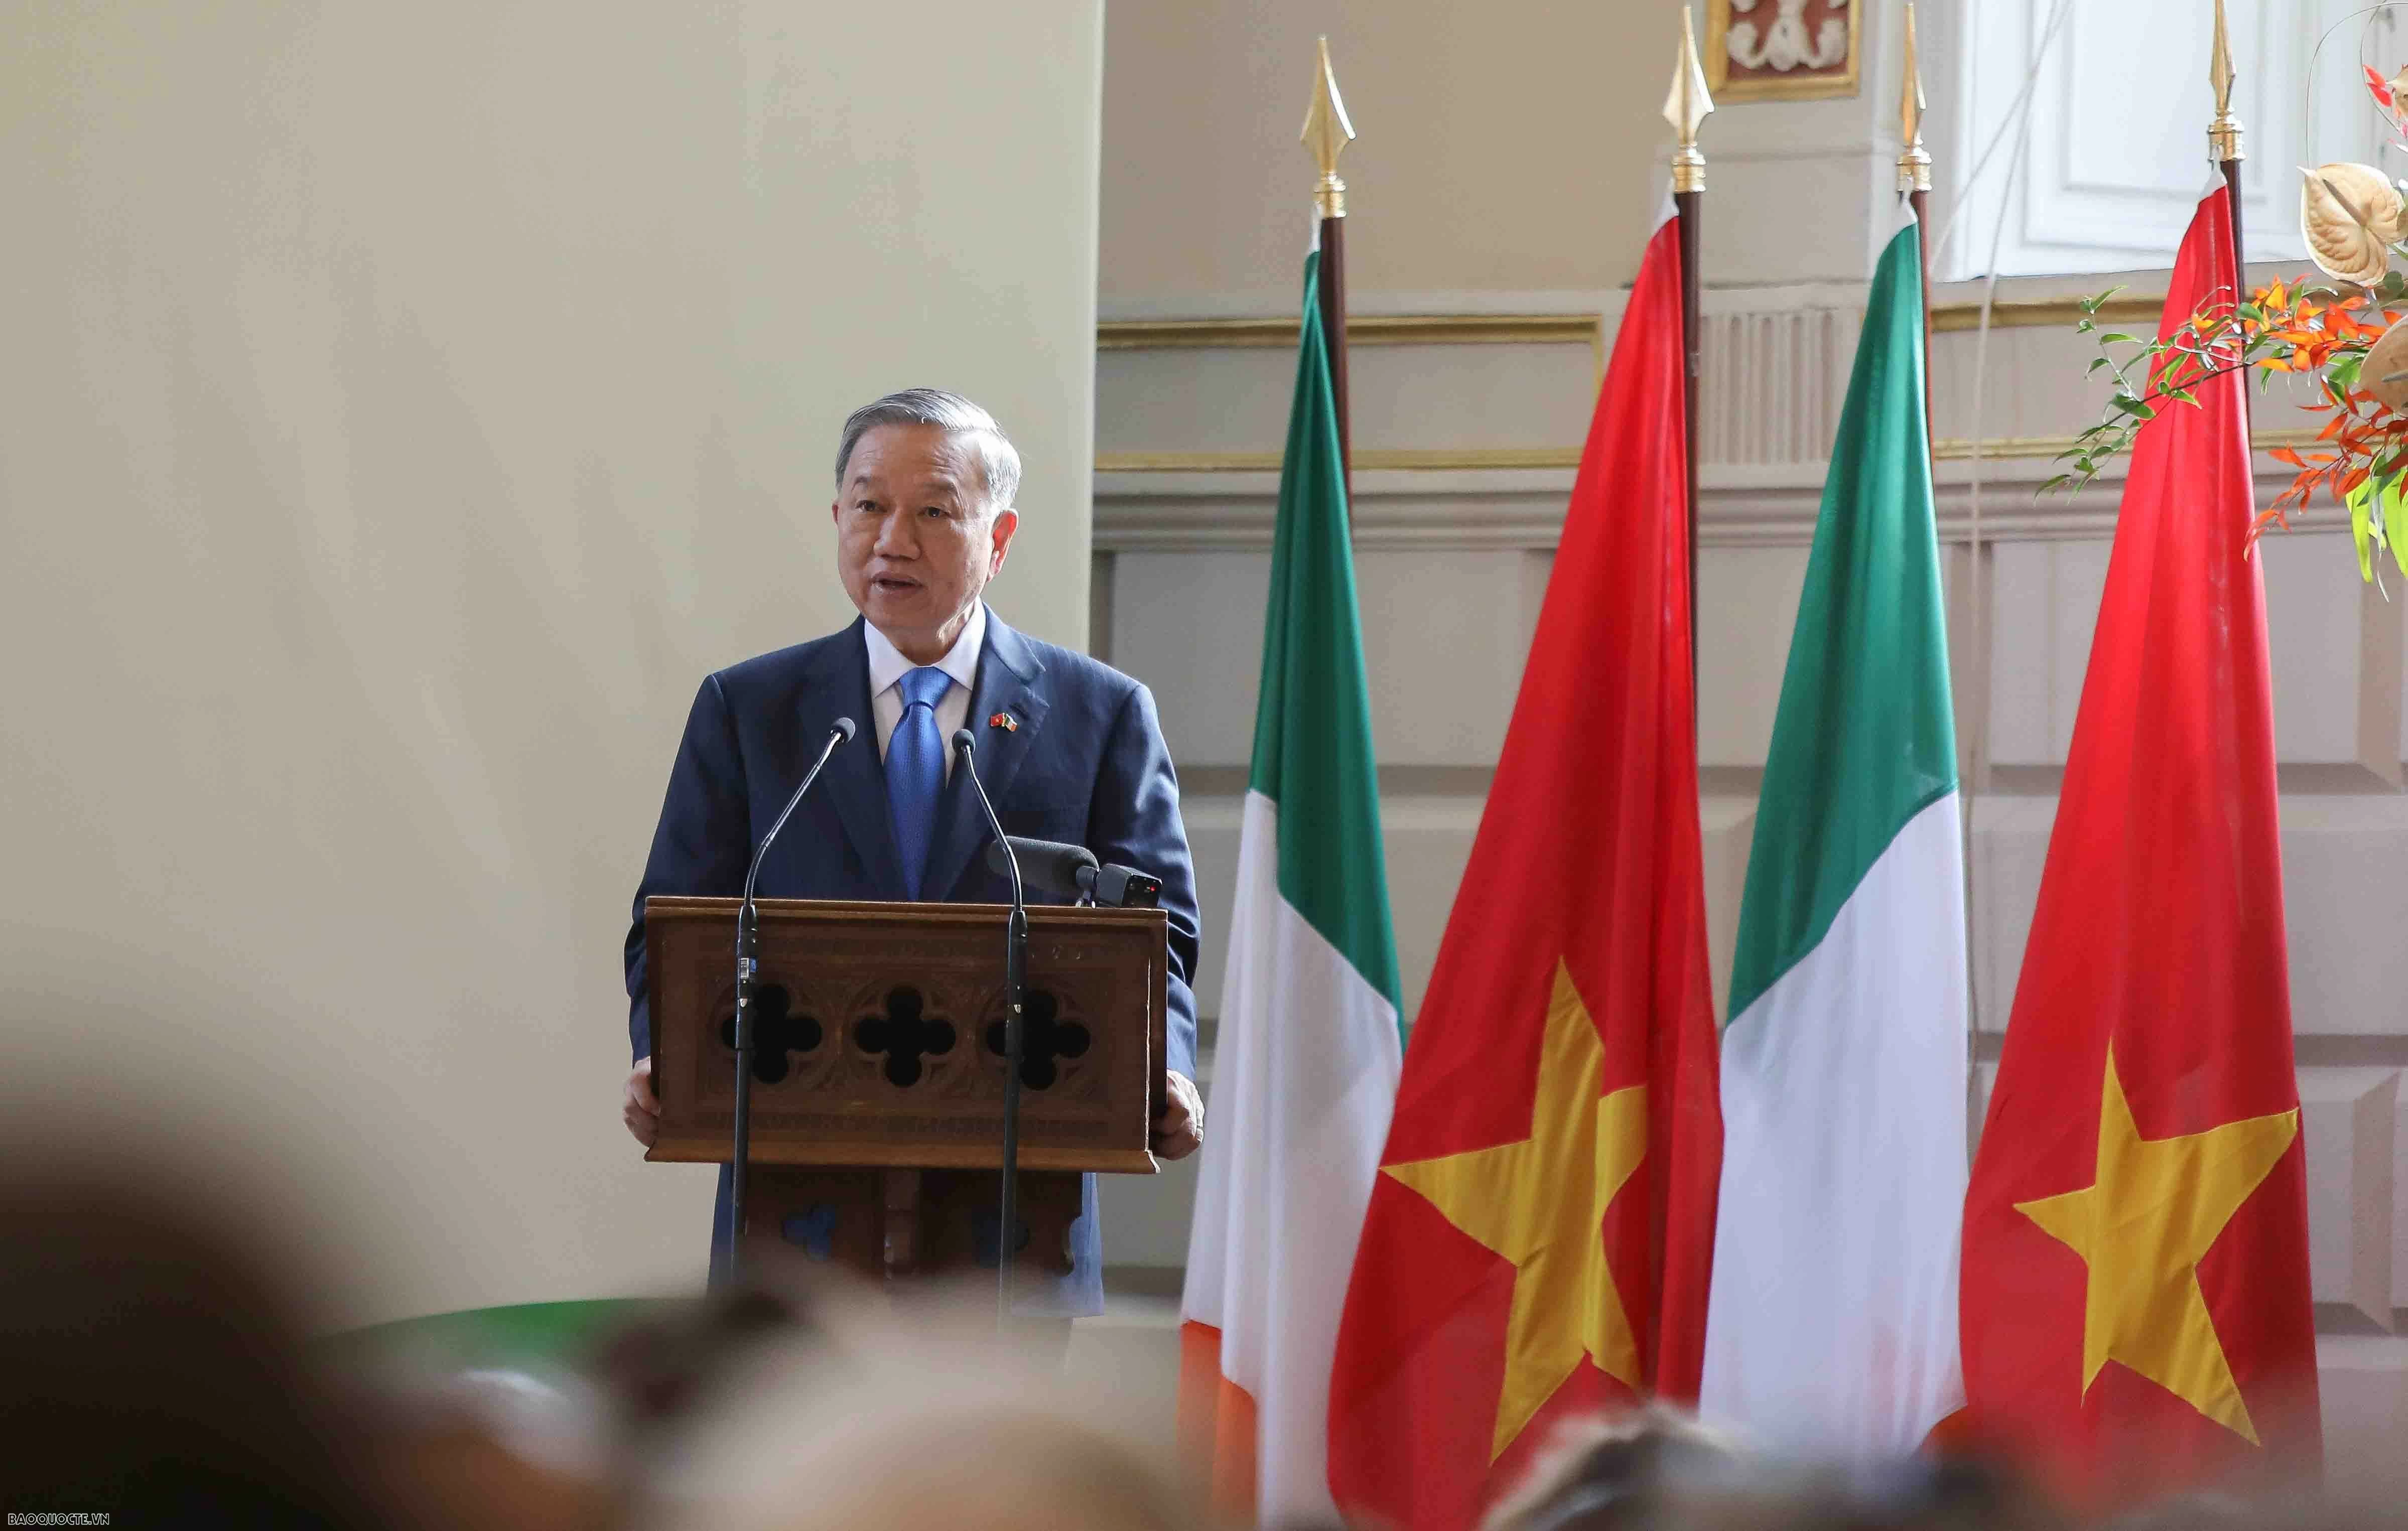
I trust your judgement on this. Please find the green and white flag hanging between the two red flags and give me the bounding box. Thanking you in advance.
[1700,209,1967,1456]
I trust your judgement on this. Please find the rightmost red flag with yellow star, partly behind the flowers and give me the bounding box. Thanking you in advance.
[1962,185,2319,1500]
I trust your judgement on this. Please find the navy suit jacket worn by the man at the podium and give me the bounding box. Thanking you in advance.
[626,607,1197,1314]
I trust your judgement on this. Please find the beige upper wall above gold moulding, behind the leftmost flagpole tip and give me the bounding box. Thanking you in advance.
[1101,0,1681,313]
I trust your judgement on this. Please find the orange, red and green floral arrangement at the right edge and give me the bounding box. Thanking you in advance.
[2042,70,2408,580]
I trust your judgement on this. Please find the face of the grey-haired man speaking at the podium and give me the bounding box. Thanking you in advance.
[833,426,1021,664]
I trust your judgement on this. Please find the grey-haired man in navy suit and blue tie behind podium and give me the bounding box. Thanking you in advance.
[624,387,1204,1314]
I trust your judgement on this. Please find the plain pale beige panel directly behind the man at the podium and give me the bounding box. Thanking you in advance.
[0,0,1101,1317]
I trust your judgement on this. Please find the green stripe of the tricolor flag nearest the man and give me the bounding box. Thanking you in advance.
[1247,250,1401,1009]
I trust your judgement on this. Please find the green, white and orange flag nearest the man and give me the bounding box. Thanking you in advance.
[1180,255,1401,1524]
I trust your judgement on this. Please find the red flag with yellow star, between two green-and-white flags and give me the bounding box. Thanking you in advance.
[1329,221,1722,1531]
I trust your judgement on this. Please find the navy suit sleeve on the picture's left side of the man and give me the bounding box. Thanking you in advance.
[626,676,751,1059]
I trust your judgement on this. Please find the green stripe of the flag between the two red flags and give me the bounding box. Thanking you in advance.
[1729,224,1958,1021]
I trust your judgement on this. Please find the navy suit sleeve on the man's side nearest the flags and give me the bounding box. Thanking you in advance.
[1089,686,1199,1078]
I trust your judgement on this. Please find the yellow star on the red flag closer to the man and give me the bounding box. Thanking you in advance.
[1387,960,1647,1461]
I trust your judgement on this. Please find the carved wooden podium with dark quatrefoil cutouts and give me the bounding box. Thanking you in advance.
[643,898,1168,1281]
